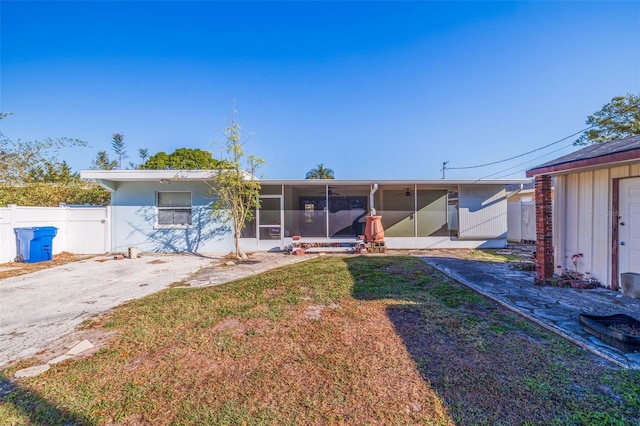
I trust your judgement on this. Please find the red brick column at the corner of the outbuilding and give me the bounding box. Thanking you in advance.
[535,175,555,281]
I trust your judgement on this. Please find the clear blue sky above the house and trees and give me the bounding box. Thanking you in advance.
[0,1,640,179]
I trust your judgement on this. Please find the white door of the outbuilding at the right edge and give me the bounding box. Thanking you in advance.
[618,178,640,273]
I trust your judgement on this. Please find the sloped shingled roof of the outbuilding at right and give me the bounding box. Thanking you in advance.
[527,135,640,177]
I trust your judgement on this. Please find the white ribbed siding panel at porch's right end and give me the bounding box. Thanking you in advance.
[458,185,507,240]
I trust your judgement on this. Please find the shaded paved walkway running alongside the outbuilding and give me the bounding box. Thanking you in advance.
[418,252,640,369]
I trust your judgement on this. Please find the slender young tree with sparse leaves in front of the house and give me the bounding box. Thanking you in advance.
[211,106,265,259]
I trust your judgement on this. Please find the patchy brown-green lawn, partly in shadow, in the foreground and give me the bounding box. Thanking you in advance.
[0,256,640,425]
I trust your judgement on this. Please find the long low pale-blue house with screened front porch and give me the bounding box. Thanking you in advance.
[81,170,528,252]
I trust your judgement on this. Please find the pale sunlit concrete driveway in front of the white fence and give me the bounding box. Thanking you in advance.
[0,254,215,367]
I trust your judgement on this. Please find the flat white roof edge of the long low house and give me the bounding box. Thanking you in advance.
[80,170,531,188]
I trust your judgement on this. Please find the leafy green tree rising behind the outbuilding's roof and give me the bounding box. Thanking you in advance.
[574,94,640,145]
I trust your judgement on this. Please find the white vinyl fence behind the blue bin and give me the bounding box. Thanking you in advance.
[0,205,111,263]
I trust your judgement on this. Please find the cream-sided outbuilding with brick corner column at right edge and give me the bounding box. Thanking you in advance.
[527,135,640,290]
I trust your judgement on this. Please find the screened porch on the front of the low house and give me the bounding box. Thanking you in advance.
[242,180,521,250]
